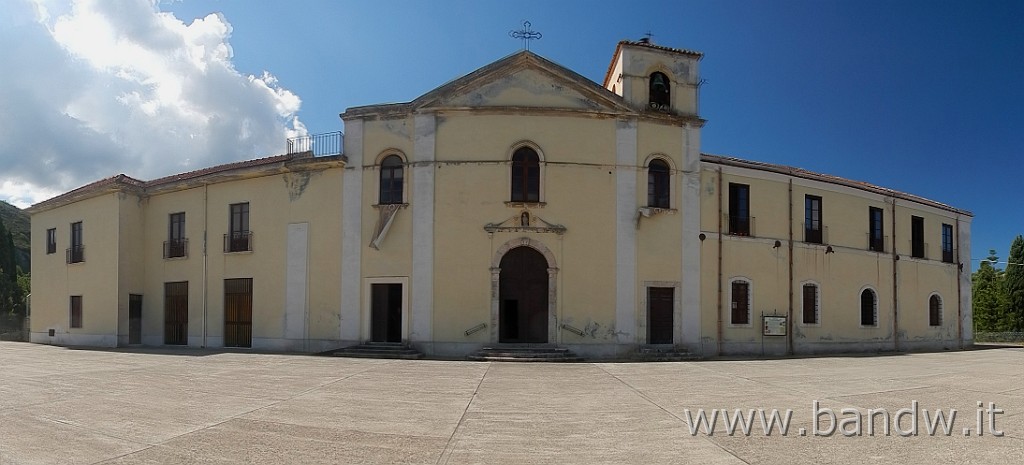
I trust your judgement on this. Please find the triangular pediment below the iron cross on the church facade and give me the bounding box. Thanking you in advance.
[412,51,632,113]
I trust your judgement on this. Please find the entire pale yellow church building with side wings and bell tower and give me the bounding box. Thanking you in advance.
[22,40,973,360]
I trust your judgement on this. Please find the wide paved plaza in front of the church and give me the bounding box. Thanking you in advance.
[0,342,1024,465]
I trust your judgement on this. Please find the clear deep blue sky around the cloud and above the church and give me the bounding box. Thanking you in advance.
[0,0,1024,266]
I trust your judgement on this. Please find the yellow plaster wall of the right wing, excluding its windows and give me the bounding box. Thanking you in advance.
[701,163,963,352]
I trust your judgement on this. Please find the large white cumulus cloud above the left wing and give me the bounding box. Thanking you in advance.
[0,0,305,207]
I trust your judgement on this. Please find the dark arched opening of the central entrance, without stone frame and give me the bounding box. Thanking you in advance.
[498,246,548,343]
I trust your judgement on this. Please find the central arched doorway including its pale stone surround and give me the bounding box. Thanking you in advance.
[490,238,558,343]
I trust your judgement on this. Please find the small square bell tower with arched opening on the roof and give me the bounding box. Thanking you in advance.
[604,38,703,117]
